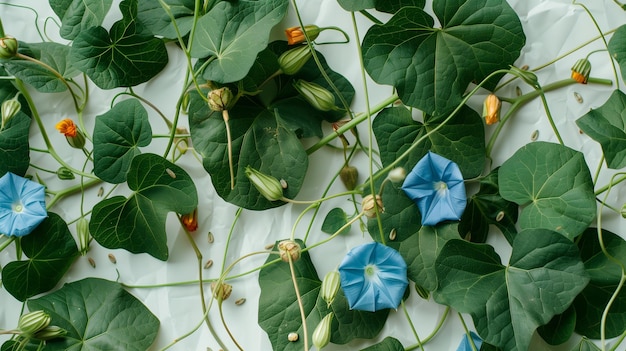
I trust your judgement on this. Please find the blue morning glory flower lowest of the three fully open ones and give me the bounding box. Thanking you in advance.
[339,242,409,312]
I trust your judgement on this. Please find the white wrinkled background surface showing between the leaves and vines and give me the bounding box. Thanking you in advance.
[0,0,626,351]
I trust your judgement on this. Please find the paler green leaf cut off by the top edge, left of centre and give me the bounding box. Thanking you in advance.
[191,0,289,83]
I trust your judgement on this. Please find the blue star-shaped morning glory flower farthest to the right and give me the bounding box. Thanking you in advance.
[402,151,467,226]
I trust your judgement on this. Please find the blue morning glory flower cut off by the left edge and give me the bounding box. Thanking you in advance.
[0,172,48,236]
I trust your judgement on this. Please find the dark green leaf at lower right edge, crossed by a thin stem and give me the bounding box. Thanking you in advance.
[574,228,626,339]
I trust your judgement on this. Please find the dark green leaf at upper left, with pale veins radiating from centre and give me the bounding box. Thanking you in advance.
[71,0,168,89]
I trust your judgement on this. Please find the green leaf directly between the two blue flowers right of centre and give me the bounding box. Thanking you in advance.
[367,184,459,291]
